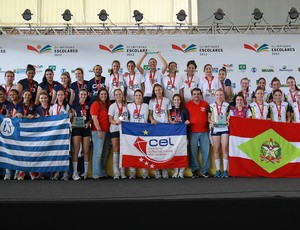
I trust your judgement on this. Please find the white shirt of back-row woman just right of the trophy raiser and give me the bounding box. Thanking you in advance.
[161,74,184,102]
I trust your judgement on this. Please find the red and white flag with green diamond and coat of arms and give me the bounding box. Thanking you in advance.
[229,117,300,177]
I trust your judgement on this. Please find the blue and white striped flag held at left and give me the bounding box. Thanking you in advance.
[0,114,70,172]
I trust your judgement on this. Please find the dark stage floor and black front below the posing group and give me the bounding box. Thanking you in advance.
[0,177,300,229]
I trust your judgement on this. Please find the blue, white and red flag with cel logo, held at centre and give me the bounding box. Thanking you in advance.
[120,122,188,169]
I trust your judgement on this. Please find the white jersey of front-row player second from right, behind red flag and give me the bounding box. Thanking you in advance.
[269,101,291,122]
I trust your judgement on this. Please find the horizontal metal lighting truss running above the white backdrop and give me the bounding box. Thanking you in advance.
[0,23,300,35]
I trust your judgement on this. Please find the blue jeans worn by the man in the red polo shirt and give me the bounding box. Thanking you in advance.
[189,132,210,174]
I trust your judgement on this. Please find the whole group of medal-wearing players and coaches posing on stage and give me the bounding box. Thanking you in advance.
[0,49,300,180]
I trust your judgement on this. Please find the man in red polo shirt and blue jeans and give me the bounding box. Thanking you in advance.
[185,88,210,178]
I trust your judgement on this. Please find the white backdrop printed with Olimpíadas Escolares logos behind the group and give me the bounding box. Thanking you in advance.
[0,34,300,92]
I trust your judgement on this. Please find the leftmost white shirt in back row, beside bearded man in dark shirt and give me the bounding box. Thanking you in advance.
[105,73,125,100]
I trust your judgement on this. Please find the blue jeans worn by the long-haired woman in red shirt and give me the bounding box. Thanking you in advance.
[92,131,109,178]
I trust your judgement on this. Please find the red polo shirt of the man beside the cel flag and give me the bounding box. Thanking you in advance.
[185,100,209,133]
